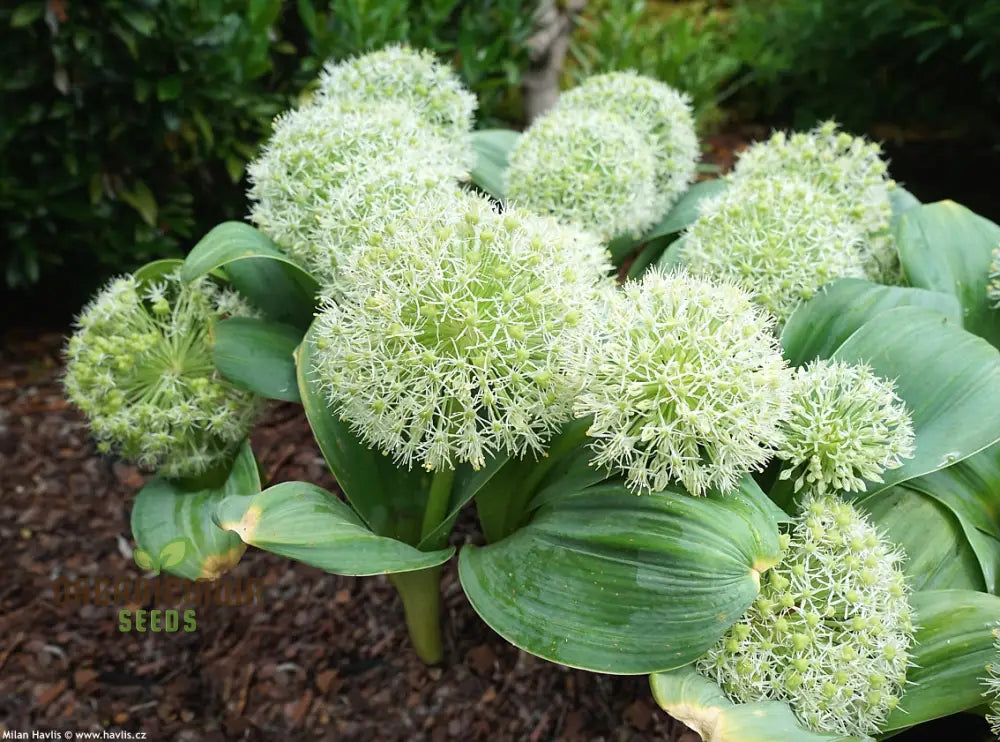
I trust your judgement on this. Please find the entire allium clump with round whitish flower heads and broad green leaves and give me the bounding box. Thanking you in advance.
[66,47,1000,739]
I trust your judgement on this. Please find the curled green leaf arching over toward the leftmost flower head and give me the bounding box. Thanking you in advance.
[181,222,319,329]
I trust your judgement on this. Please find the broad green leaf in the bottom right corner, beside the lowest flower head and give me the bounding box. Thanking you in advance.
[882,590,1000,732]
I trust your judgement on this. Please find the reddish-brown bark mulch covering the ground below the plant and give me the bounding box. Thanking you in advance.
[0,335,698,742]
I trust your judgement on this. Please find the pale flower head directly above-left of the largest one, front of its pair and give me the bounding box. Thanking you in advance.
[247,103,464,283]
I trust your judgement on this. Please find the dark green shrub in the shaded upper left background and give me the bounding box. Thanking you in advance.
[0,0,534,301]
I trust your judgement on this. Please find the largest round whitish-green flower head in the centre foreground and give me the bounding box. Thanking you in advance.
[314,194,610,469]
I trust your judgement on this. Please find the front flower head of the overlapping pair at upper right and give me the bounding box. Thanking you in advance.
[681,177,865,324]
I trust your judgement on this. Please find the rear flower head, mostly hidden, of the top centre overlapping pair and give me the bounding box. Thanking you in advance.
[556,70,701,216]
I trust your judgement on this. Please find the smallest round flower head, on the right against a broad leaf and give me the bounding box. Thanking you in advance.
[775,360,914,494]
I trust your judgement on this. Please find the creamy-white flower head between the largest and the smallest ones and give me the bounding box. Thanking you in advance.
[576,270,788,495]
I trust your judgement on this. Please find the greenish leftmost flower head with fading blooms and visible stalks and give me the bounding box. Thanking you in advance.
[64,273,260,477]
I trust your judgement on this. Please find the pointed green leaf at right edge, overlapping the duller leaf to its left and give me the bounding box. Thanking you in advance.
[907,445,1000,593]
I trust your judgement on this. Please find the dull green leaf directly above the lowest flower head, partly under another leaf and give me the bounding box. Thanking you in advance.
[862,488,986,590]
